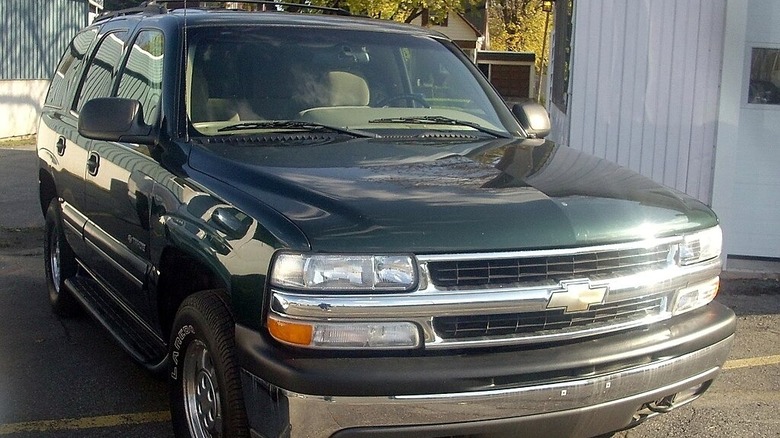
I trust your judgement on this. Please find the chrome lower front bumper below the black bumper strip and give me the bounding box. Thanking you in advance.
[242,336,734,438]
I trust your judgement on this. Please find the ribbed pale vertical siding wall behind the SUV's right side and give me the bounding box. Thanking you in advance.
[553,0,726,203]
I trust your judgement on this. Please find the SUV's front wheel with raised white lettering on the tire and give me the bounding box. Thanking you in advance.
[169,290,249,438]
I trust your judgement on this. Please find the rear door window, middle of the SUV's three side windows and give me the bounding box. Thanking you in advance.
[74,31,127,112]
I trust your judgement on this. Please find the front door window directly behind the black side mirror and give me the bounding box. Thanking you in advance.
[117,30,163,124]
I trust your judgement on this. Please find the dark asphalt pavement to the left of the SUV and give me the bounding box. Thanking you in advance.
[0,143,172,438]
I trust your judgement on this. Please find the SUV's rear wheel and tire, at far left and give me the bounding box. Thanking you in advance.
[43,198,81,317]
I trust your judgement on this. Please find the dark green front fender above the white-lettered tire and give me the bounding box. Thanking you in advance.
[150,170,309,329]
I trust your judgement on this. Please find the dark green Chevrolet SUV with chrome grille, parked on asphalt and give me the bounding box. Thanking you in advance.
[38,2,735,438]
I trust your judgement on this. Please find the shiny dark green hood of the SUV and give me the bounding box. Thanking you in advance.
[189,137,717,253]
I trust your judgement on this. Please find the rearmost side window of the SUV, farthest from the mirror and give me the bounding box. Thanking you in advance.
[46,29,97,107]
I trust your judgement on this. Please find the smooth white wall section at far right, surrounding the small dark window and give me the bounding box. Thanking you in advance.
[713,0,780,258]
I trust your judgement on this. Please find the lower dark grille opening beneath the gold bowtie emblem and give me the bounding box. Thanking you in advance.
[433,297,665,339]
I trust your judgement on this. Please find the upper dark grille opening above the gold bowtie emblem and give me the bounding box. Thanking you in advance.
[428,244,672,287]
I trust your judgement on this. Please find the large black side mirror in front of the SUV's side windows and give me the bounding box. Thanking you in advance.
[79,97,155,144]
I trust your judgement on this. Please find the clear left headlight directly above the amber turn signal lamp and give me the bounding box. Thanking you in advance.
[270,253,417,292]
